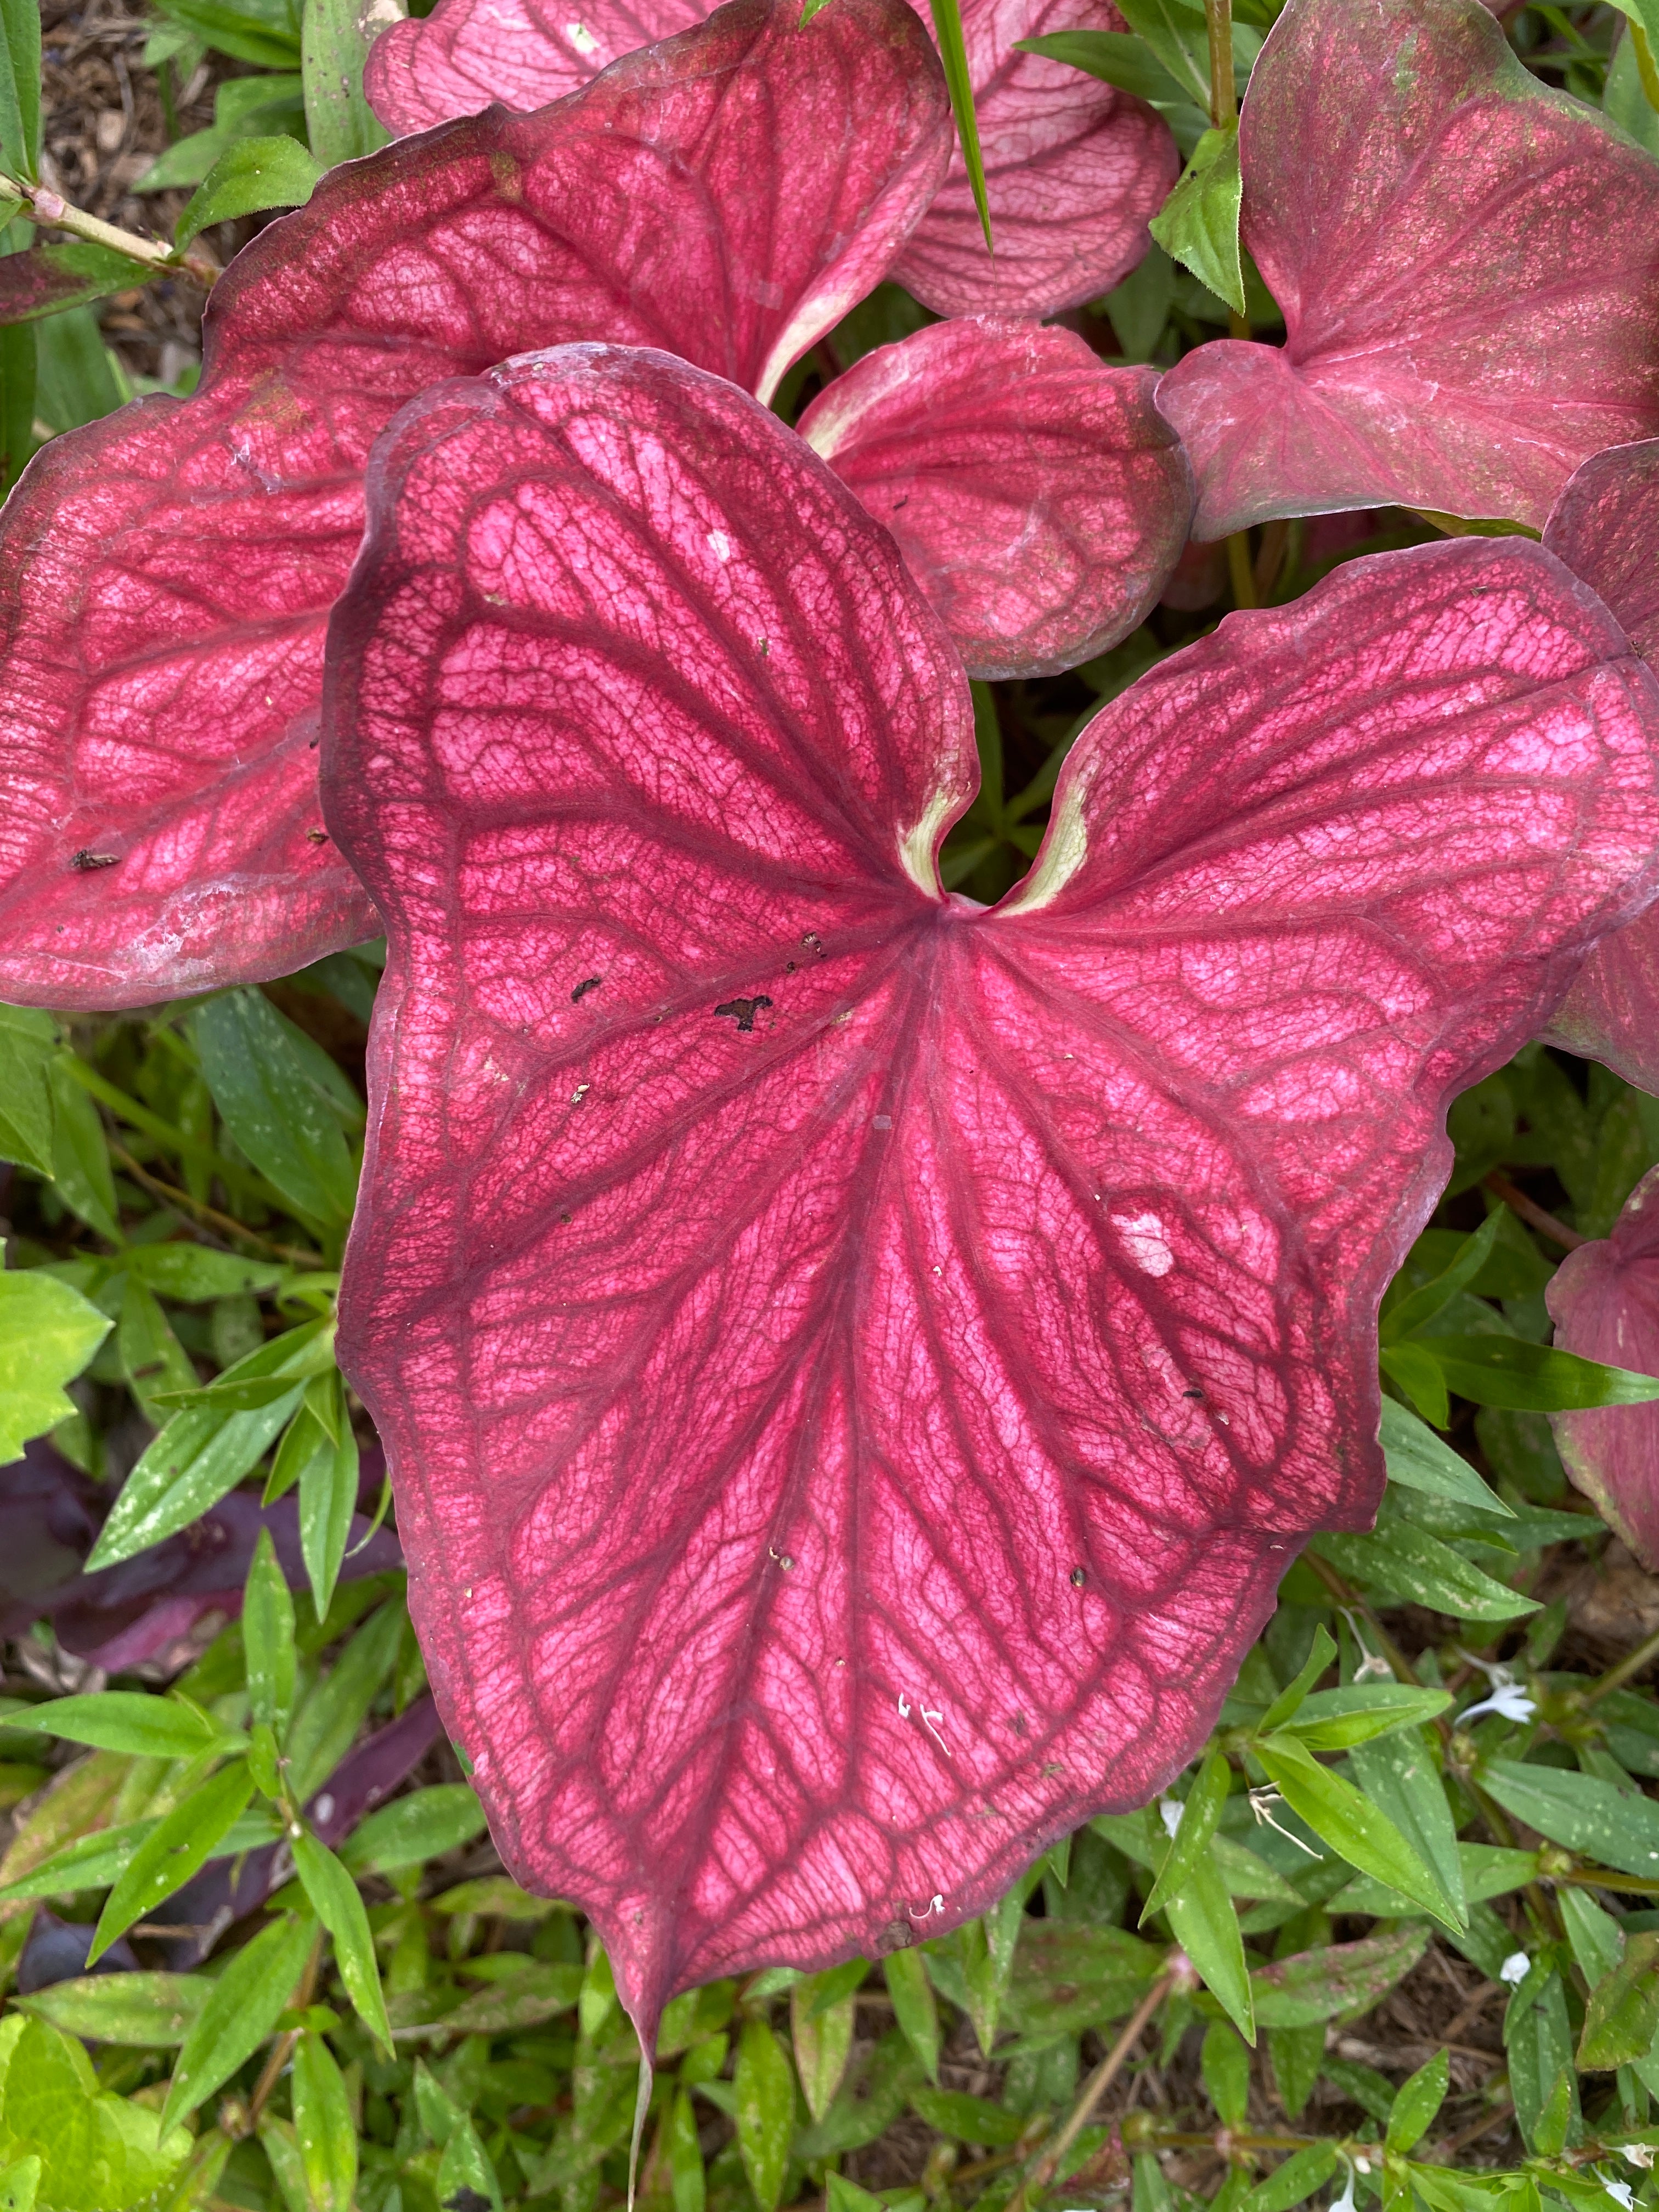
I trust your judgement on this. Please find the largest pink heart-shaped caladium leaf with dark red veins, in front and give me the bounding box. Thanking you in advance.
[323,347,1659,2046]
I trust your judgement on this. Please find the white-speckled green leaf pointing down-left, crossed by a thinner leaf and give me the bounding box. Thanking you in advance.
[86,1321,334,1568]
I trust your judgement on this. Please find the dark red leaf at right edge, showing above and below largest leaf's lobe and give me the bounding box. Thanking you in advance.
[1544,438,1659,1091]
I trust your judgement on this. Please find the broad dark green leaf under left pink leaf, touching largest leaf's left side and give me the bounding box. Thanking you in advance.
[186,991,360,1226]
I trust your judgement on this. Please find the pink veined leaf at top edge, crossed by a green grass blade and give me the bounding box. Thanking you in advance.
[896,0,1181,317]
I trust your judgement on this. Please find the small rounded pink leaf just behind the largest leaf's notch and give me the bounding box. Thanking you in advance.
[801,317,1192,677]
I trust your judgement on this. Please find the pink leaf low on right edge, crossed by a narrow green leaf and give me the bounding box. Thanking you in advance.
[1544,1168,1659,1573]
